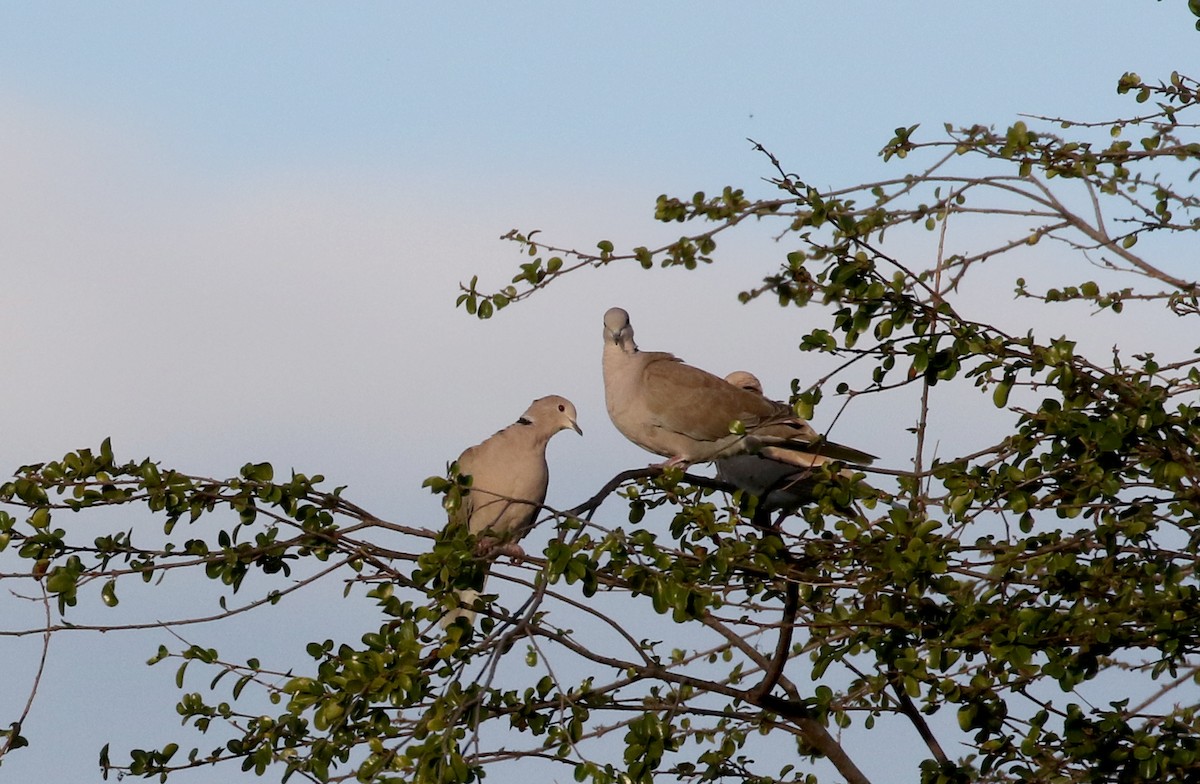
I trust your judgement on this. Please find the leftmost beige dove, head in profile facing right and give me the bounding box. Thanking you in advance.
[442,395,583,628]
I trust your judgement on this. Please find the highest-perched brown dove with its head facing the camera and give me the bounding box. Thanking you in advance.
[604,307,875,467]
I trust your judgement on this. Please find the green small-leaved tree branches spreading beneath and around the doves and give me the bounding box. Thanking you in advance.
[0,73,1200,784]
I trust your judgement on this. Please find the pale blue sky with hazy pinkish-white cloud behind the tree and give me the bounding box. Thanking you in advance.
[0,6,1200,782]
